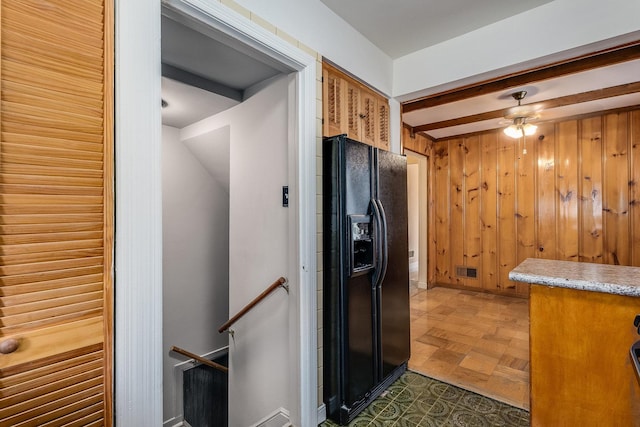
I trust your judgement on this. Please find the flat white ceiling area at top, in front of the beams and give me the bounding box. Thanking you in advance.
[320,0,552,59]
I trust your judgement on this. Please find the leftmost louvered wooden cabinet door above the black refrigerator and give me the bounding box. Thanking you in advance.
[322,69,347,136]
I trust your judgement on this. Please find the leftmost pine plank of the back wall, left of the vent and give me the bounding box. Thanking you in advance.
[434,141,452,283]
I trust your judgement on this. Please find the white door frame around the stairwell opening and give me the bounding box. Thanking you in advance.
[114,0,318,427]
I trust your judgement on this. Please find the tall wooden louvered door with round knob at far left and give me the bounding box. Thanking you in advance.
[0,0,113,426]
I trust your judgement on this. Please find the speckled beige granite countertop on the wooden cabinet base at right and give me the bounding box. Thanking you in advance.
[509,258,640,297]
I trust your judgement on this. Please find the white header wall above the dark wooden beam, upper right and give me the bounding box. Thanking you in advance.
[393,0,640,101]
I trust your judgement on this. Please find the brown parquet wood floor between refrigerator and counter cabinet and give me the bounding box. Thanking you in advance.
[409,286,529,410]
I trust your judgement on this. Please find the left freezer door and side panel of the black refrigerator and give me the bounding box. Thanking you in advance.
[323,136,378,422]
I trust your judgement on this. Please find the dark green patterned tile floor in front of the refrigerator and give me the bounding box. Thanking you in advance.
[321,371,529,427]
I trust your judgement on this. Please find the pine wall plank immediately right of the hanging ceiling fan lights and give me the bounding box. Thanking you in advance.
[536,124,557,259]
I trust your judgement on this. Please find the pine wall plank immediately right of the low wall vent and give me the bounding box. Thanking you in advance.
[479,132,499,290]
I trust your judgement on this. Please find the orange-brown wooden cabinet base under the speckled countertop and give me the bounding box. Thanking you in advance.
[529,285,640,427]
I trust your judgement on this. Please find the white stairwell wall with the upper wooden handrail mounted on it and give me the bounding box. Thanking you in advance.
[180,76,295,426]
